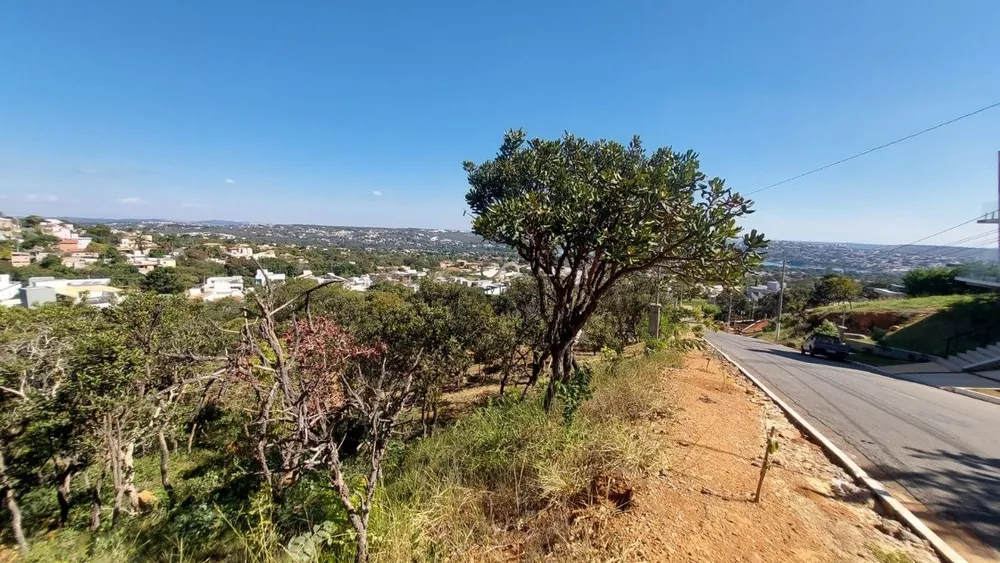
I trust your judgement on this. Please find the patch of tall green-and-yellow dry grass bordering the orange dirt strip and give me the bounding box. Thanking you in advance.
[373,351,681,562]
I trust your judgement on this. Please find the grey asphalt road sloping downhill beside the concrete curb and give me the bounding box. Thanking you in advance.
[707,333,1000,558]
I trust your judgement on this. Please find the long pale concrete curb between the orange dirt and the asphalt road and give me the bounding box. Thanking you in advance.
[705,339,968,563]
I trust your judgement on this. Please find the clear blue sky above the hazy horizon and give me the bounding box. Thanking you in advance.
[0,0,1000,243]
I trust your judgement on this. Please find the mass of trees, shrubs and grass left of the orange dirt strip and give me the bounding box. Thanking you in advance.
[0,132,766,561]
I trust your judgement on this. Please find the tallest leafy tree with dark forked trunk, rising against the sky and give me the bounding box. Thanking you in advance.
[465,131,766,406]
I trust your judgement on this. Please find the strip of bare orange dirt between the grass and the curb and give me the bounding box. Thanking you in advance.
[605,353,937,563]
